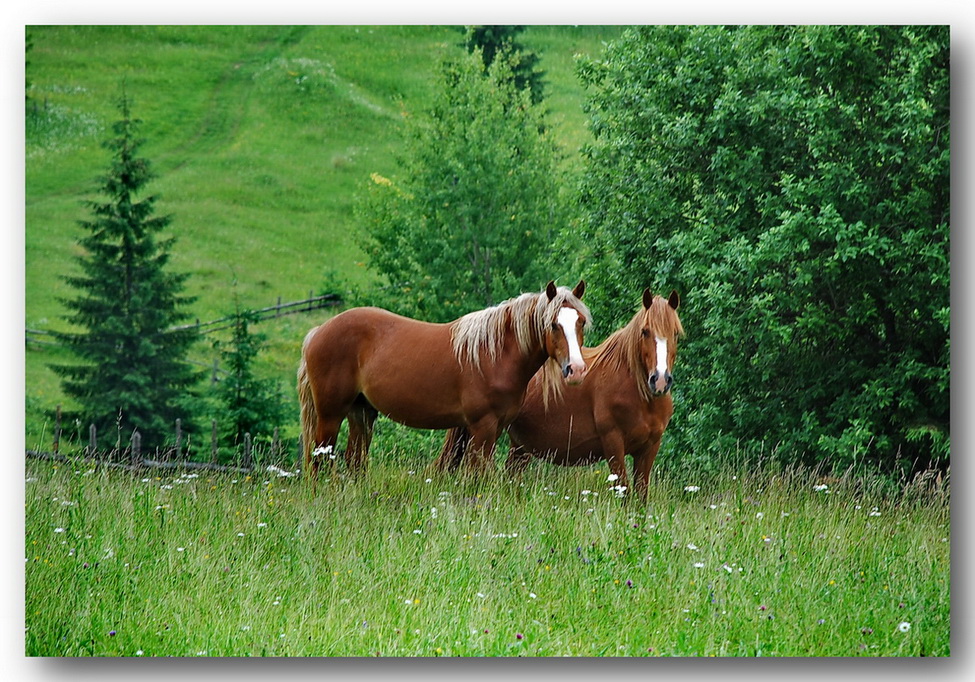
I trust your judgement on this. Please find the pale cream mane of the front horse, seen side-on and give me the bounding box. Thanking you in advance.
[450,287,592,372]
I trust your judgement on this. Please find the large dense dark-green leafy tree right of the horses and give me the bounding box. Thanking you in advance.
[581,26,950,467]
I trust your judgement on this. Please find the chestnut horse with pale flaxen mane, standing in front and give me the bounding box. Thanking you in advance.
[298,280,592,480]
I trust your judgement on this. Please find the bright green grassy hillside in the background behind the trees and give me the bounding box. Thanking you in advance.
[25,26,619,445]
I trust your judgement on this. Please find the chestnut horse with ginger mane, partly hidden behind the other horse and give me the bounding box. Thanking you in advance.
[434,289,684,499]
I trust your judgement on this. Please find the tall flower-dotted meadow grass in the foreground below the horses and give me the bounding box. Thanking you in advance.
[25,452,950,657]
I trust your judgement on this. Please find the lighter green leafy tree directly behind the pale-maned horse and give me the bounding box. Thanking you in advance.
[361,51,566,321]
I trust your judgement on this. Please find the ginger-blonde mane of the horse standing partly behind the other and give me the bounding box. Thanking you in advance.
[541,296,684,402]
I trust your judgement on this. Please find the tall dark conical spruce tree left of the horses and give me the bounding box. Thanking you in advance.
[54,91,198,447]
